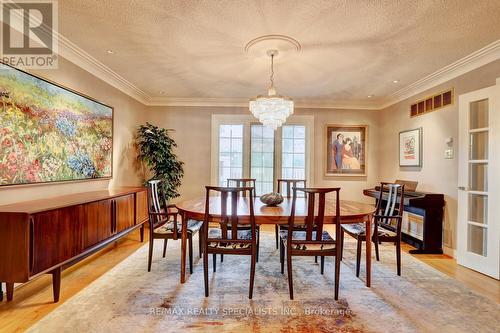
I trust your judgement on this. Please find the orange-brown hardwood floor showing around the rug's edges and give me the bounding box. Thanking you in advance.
[0,226,500,332]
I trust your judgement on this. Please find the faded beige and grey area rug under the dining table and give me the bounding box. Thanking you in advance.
[30,228,500,333]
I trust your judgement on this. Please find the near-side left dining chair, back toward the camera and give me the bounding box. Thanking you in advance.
[203,186,258,299]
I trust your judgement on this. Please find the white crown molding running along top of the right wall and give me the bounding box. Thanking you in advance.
[378,39,500,109]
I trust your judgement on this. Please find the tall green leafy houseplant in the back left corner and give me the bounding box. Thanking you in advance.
[137,123,184,200]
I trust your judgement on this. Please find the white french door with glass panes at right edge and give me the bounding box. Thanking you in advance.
[457,84,500,279]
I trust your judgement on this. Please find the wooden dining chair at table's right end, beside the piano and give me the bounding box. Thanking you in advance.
[341,182,405,277]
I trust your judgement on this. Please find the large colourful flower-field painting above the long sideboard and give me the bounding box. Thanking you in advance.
[0,63,113,186]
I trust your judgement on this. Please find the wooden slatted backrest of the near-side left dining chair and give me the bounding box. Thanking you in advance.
[204,186,255,241]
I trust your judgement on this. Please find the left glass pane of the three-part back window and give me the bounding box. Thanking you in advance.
[219,125,243,186]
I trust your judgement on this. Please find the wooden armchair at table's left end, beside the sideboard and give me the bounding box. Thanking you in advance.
[148,180,203,274]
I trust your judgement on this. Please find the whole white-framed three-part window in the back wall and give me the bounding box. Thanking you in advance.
[211,114,314,195]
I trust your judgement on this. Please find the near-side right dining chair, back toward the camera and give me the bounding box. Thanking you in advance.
[280,187,340,300]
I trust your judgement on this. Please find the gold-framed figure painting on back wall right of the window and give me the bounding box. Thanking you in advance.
[325,125,368,176]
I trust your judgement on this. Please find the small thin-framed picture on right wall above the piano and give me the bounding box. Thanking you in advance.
[399,128,422,167]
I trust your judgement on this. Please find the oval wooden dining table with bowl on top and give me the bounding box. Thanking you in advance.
[175,196,375,287]
